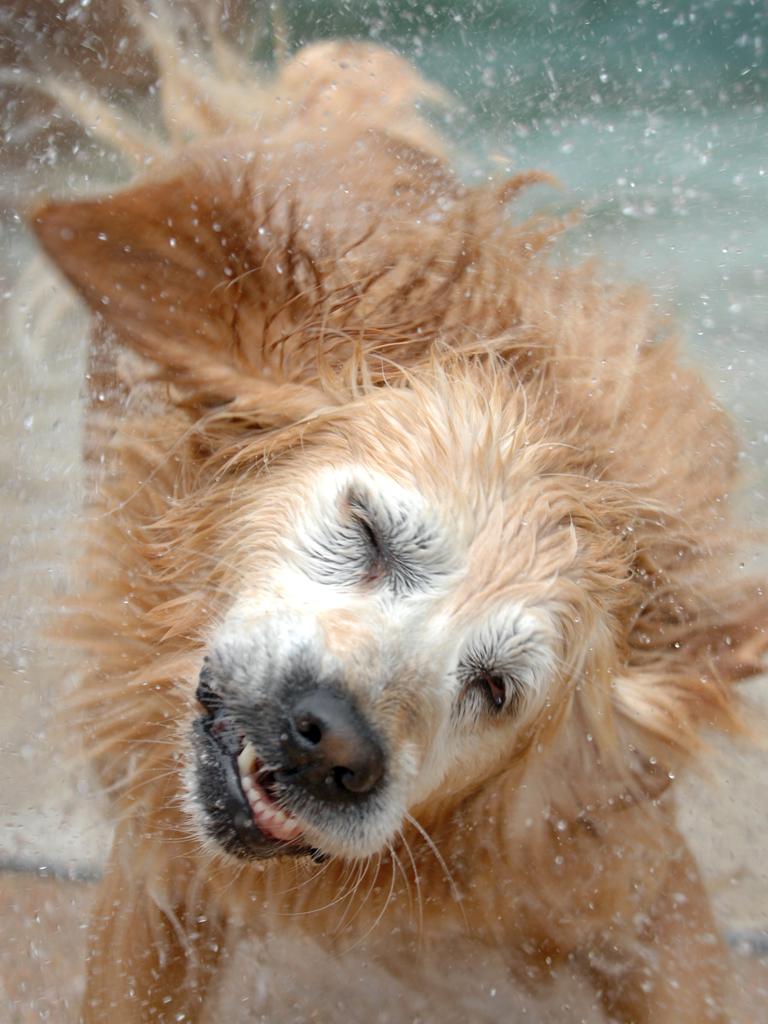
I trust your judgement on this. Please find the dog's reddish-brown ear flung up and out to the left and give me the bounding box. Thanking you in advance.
[30,148,329,421]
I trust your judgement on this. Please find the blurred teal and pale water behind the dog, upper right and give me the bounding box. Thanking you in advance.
[274,0,768,495]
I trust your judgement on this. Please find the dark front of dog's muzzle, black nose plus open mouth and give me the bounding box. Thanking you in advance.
[195,668,386,858]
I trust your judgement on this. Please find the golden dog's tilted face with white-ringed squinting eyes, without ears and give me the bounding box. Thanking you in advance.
[187,374,626,857]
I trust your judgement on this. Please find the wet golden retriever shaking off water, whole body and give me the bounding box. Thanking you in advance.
[30,23,768,1024]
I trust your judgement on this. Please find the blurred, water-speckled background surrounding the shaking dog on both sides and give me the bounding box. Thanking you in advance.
[0,0,768,1022]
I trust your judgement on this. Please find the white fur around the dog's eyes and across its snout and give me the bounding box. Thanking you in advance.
[207,468,556,856]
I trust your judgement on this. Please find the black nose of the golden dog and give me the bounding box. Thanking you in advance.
[275,689,384,801]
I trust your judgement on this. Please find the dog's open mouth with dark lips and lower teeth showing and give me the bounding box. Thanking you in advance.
[195,711,321,859]
